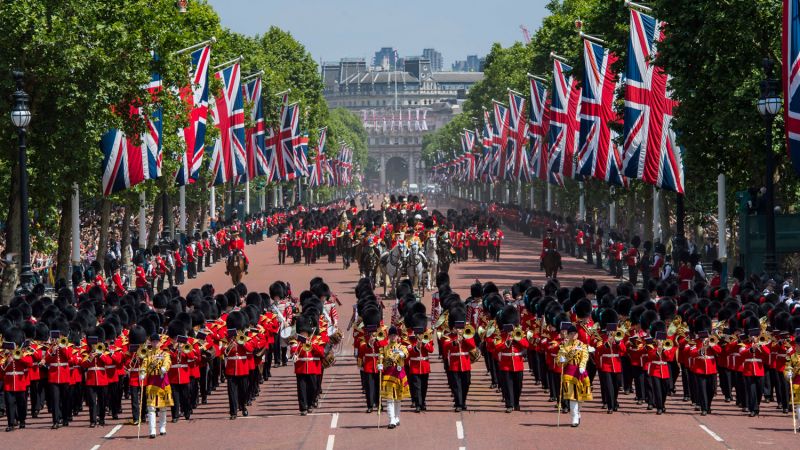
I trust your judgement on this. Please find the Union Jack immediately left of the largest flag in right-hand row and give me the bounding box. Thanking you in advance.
[578,40,626,186]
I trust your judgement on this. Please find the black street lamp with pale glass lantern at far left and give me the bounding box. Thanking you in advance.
[11,70,33,291]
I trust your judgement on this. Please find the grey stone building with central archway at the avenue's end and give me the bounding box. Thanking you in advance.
[322,56,483,190]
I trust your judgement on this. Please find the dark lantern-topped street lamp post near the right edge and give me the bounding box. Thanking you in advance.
[758,58,781,277]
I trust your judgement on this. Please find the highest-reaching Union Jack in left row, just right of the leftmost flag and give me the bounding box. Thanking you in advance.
[175,46,211,186]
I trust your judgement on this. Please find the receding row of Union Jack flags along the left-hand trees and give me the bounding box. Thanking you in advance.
[100,46,353,196]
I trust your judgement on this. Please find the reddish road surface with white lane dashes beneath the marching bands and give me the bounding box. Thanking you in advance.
[1,204,800,450]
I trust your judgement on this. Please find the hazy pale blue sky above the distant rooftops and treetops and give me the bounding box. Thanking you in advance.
[206,0,547,69]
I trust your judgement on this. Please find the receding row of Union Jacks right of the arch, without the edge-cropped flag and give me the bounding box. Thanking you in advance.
[433,10,684,194]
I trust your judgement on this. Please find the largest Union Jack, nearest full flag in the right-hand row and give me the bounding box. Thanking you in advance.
[623,10,683,194]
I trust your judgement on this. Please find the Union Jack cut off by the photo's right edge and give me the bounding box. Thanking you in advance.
[782,0,800,173]
